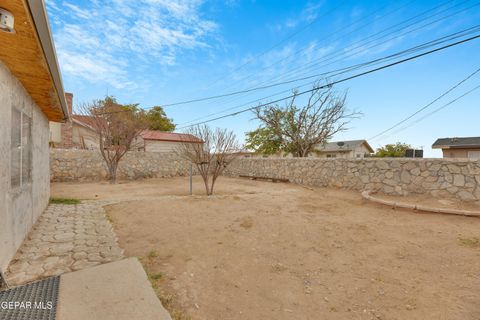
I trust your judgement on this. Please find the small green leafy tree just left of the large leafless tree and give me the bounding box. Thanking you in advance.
[245,127,283,155]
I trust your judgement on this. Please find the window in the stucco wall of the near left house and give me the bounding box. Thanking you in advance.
[10,108,32,188]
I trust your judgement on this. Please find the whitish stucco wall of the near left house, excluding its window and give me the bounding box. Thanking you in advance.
[0,61,50,270]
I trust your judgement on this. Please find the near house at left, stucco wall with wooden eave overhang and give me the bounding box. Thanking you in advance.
[0,0,68,270]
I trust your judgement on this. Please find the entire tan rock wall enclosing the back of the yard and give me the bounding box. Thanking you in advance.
[50,149,480,201]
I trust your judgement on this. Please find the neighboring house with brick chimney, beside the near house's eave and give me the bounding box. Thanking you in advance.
[50,92,99,149]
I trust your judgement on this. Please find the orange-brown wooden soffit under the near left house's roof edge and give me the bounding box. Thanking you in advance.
[0,0,66,122]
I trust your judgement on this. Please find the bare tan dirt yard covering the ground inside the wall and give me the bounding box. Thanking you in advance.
[52,178,480,320]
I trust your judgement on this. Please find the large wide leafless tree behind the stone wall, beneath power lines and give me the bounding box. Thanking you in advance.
[254,85,361,157]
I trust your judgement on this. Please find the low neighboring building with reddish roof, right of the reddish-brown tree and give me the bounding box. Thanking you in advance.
[135,130,203,153]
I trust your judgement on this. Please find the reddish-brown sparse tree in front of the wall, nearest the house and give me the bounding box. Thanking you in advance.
[80,97,146,183]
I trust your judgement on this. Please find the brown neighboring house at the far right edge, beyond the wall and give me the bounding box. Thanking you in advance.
[432,137,480,160]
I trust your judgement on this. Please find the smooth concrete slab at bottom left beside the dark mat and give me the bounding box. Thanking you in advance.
[57,258,171,320]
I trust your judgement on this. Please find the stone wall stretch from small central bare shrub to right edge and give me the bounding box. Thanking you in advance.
[227,158,480,201]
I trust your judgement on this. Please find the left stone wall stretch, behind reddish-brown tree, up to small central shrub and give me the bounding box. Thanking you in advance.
[50,149,189,182]
